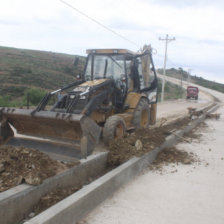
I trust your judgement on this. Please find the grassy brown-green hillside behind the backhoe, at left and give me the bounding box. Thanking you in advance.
[0,47,85,105]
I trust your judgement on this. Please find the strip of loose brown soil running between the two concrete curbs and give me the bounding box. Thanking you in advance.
[24,118,190,220]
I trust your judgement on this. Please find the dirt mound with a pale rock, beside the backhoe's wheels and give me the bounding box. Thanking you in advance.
[108,117,190,166]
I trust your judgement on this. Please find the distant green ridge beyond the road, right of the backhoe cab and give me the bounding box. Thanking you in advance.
[158,68,224,93]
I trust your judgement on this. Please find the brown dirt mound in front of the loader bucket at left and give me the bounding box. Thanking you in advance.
[0,146,76,192]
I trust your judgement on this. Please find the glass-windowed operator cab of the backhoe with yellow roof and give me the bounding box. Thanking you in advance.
[83,49,157,103]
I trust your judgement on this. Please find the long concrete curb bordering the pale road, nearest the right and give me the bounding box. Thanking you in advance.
[25,106,218,224]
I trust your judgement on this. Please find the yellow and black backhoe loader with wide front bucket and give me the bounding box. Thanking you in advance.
[0,46,157,156]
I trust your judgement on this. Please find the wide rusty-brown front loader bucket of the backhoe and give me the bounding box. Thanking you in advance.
[0,108,101,156]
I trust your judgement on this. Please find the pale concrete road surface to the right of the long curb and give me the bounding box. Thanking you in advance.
[80,80,224,224]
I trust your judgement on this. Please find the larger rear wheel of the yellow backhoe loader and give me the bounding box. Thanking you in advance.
[133,98,150,129]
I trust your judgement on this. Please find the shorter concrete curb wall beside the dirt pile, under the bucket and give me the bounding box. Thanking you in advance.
[0,152,108,224]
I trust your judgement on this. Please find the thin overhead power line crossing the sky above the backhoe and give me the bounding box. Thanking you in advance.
[60,0,140,47]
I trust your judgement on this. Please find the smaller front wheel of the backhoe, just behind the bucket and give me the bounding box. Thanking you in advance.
[103,115,126,145]
